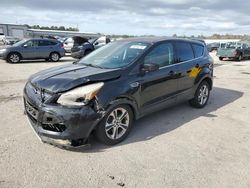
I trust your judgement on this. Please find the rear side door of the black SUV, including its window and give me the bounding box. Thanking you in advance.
[175,41,204,98]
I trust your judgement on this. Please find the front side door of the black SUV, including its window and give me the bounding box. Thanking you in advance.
[140,42,178,112]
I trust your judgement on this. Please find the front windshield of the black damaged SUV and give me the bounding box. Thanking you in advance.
[79,42,150,69]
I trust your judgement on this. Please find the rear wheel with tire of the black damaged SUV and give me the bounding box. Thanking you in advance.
[189,81,210,108]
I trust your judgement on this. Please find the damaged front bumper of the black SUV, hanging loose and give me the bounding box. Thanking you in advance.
[24,87,102,148]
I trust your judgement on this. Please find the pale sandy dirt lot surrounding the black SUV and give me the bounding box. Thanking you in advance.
[0,53,250,188]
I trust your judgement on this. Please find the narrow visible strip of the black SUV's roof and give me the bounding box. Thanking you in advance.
[118,37,204,45]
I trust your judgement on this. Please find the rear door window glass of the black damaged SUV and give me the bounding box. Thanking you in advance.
[175,42,194,63]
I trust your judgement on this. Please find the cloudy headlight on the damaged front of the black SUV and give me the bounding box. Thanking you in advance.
[57,82,104,106]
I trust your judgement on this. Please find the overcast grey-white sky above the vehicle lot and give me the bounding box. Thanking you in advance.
[0,0,250,36]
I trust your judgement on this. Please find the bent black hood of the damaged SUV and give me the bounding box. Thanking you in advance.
[29,64,121,93]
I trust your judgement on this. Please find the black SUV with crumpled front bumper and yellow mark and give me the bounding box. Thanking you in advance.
[24,38,213,147]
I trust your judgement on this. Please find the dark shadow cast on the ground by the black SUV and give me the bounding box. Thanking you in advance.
[75,87,243,153]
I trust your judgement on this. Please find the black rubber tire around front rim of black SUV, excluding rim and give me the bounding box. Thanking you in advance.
[96,104,134,145]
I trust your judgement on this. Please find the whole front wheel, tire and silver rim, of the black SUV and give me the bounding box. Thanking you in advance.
[95,105,134,145]
